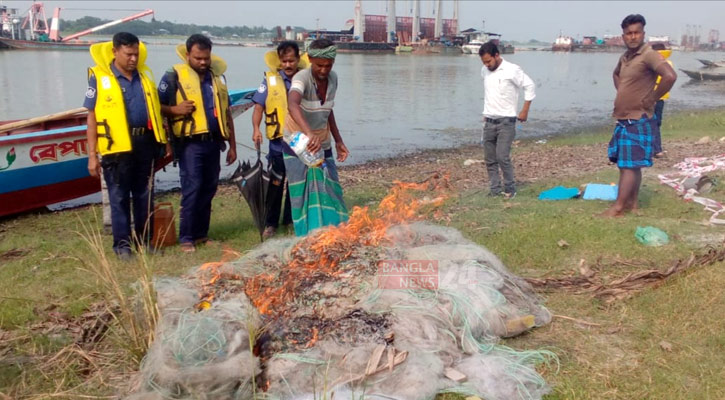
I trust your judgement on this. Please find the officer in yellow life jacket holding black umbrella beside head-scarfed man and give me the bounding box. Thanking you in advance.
[252,41,309,239]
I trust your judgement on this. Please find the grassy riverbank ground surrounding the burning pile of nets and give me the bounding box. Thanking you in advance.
[0,110,725,399]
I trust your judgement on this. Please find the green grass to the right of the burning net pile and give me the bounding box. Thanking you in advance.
[446,173,725,399]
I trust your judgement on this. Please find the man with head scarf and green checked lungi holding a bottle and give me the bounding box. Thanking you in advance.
[284,39,349,236]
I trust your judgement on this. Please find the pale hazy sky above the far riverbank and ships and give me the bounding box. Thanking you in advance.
[0,0,725,42]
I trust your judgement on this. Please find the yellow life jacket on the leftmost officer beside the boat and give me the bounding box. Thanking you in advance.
[88,42,166,156]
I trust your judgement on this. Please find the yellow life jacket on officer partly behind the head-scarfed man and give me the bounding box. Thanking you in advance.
[264,50,310,140]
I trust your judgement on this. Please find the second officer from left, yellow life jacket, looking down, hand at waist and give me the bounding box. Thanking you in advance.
[159,34,237,252]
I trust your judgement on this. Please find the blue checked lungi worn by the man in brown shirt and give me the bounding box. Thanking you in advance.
[607,114,659,168]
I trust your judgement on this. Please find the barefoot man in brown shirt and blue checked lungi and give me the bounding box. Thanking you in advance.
[602,14,677,217]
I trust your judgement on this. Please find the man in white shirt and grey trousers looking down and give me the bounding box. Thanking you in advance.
[478,42,536,198]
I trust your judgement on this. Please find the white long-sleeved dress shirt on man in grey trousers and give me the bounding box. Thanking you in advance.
[481,59,536,118]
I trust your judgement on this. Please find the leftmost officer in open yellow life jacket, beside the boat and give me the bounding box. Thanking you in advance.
[83,32,171,259]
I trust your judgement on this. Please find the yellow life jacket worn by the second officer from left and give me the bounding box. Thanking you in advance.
[172,44,229,139]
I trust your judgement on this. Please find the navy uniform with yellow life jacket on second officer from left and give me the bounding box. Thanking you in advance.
[158,45,230,244]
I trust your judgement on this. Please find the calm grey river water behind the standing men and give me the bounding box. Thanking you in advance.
[0,44,725,202]
